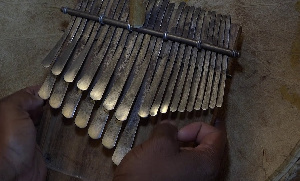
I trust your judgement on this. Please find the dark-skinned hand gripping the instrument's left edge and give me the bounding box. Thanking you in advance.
[0,87,46,181]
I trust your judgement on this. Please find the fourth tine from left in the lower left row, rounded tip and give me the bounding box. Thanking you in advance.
[75,0,129,128]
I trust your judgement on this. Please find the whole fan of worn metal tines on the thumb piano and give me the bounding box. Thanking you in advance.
[39,0,240,170]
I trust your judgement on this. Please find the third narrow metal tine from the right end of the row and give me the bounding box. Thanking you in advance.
[202,14,221,110]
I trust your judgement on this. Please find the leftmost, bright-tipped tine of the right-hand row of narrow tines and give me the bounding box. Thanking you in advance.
[139,3,185,117]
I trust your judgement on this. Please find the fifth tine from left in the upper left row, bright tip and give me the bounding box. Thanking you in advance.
[90,1,154,100]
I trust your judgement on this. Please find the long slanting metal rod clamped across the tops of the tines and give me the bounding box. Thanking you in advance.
[61,7,240,57]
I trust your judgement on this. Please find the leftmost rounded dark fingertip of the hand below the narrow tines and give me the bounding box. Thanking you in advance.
[149,121,179,153]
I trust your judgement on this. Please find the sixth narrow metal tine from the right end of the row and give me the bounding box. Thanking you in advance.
[178,8,203,112]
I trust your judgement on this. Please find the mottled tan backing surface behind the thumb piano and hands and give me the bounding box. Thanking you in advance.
[0,0,300,181]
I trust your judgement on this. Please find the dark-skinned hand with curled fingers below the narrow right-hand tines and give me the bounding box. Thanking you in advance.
[114,121,226,181]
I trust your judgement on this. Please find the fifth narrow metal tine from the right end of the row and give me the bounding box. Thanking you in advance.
[186,10,207,112]
